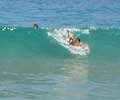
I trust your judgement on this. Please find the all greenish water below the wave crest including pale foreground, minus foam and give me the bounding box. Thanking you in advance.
[0,27,120,100]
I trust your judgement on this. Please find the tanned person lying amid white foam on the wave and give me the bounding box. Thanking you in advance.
[67,30,82,46]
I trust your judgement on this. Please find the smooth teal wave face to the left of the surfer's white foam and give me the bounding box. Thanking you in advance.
[0,28,72,57]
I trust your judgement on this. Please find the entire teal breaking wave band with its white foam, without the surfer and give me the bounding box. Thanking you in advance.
[0,27,120,57]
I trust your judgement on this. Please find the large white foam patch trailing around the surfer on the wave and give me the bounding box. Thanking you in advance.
[48,28,90,55]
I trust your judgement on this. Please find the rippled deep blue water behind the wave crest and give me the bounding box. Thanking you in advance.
[0,0,120,27]
